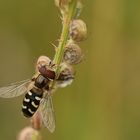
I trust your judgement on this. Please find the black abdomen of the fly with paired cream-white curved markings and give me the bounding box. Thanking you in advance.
[22,88,43,117]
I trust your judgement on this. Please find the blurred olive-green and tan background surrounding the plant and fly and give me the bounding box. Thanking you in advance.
[0,0,140,140]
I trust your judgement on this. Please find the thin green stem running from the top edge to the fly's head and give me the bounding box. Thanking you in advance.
[54,0,77,76]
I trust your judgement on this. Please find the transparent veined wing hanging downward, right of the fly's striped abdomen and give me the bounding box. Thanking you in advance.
[40,95,55,133]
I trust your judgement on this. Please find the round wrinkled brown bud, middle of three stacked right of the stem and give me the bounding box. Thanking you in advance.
[63,42,83,65]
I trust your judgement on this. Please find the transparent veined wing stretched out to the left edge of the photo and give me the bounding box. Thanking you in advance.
[0,79,31,98]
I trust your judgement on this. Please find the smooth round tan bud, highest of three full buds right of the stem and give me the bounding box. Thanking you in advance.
[69,19,87,42]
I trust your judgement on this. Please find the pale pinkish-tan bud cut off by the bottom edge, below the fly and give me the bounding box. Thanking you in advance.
[17,127,41,140]
